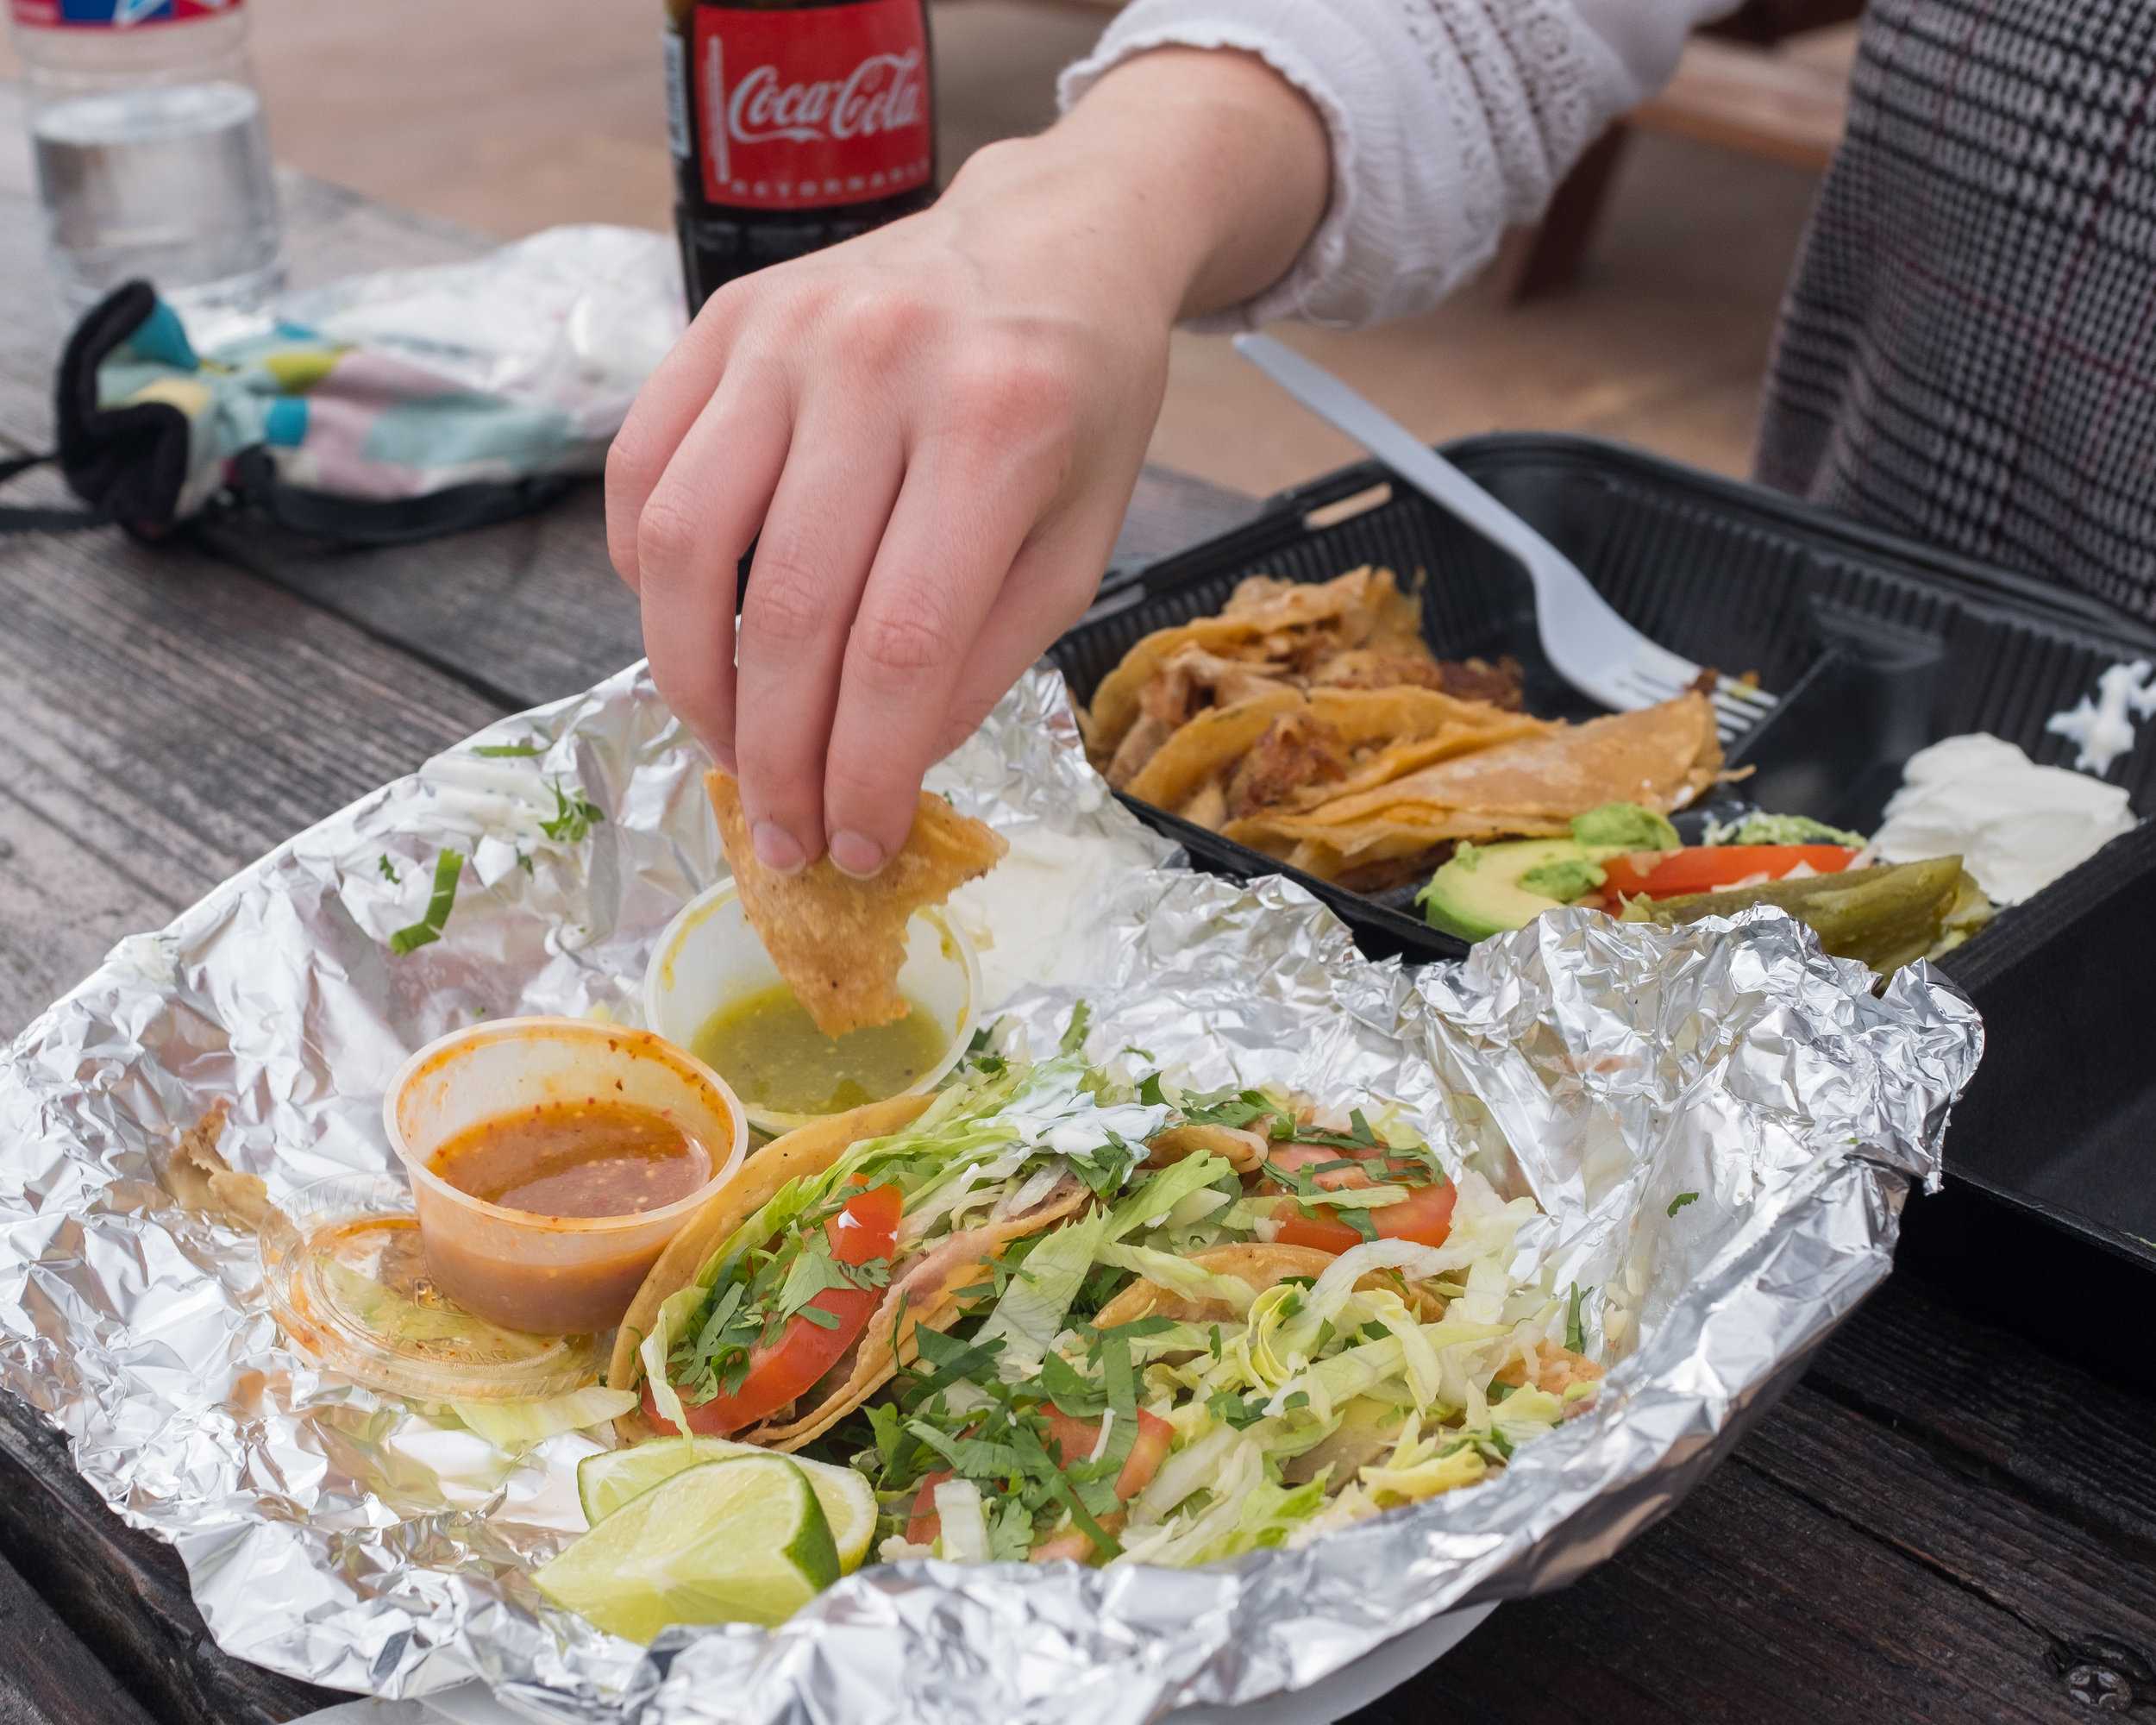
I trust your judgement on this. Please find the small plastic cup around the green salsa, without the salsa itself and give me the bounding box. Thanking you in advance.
[645,880,981,1137]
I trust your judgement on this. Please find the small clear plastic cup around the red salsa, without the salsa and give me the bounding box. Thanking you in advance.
[382,1018,749,1335]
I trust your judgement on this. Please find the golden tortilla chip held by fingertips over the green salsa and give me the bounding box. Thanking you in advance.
[703,772,1009,1038]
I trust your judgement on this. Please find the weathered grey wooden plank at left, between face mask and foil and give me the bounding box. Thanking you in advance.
[0,466,503,1031]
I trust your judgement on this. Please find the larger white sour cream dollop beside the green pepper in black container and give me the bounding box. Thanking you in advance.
[1871,731,2134,904]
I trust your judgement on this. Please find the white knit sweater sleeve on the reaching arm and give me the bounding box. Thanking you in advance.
[1061,0,1733,328]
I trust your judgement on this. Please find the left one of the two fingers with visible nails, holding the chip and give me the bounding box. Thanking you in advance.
[736,410,904,871]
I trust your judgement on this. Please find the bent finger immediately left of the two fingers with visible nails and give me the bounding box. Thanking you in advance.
[630,369,792,772]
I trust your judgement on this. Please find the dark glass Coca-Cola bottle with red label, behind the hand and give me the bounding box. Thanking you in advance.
[667,0,936,313]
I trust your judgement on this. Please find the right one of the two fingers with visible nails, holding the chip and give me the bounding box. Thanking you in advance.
[824,442,1065,875]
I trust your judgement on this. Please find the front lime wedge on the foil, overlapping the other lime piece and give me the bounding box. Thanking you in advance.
[533,1452,839,1641]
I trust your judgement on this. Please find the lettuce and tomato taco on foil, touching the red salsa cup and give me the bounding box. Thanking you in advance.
[608,1057,1164,1449]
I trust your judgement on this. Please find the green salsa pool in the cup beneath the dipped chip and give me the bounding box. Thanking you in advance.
[690,983,951,1115]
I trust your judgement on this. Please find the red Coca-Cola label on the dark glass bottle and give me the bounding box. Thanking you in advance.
[690,0,934,210]
